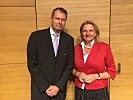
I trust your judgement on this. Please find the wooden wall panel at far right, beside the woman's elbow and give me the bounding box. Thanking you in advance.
[110,0,133,100]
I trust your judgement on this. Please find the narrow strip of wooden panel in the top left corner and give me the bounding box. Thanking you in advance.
[0,0,35,7]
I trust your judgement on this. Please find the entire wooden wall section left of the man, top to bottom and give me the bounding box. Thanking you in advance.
[0,0,36,100]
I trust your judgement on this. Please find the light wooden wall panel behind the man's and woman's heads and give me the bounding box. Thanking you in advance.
[37,0,110,100]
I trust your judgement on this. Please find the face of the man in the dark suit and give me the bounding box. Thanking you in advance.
[51,10,67,33]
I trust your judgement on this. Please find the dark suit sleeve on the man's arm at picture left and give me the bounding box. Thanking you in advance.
[27,32,49,92]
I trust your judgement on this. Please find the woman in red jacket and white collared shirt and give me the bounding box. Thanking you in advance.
[73,20,116,100]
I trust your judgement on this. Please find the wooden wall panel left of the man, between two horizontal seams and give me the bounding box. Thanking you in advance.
[0,7,36,64]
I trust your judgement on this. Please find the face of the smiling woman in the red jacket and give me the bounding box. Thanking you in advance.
[81,24,96,42]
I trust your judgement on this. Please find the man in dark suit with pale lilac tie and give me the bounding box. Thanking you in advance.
[27,7,74,100]
